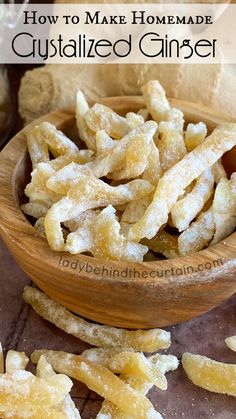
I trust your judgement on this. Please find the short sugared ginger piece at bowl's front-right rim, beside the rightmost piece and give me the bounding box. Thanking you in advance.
[178,207,215,256]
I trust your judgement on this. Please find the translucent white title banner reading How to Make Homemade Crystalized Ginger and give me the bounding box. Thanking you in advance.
[0,4,236,64]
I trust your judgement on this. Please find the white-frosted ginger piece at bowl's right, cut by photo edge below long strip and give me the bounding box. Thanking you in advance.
[211,173,236,244]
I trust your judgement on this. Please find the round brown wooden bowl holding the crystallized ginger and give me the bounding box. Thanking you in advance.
[0,97,236,328]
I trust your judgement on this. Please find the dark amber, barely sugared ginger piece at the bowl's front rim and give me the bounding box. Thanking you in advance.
[142,230,179,259]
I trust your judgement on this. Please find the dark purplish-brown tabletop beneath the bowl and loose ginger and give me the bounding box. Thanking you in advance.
[0,241,236,419]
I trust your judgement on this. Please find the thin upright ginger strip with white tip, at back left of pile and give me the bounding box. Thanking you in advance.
[75,90,96,150]
